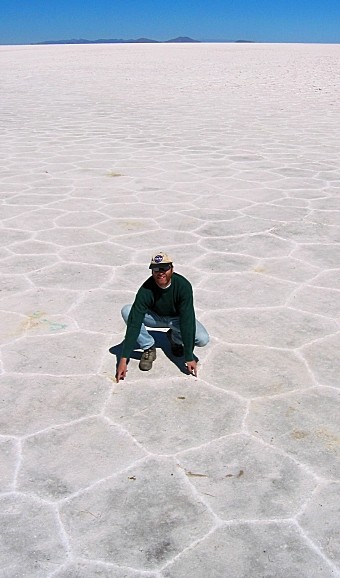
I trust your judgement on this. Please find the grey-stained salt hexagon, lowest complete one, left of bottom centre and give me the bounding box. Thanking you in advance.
[61,460,213,570]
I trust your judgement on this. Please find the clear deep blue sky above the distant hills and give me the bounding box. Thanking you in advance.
[0,0,340,44]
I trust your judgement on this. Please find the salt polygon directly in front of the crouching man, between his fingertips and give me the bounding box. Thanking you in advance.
[106,379,245,454]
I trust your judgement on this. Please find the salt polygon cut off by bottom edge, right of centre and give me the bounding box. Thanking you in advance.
[162,522,334,578]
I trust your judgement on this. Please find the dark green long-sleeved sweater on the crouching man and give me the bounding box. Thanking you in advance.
[122,273,196,361]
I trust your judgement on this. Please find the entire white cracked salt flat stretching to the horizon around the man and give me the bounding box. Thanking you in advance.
[0,43,340,578]
